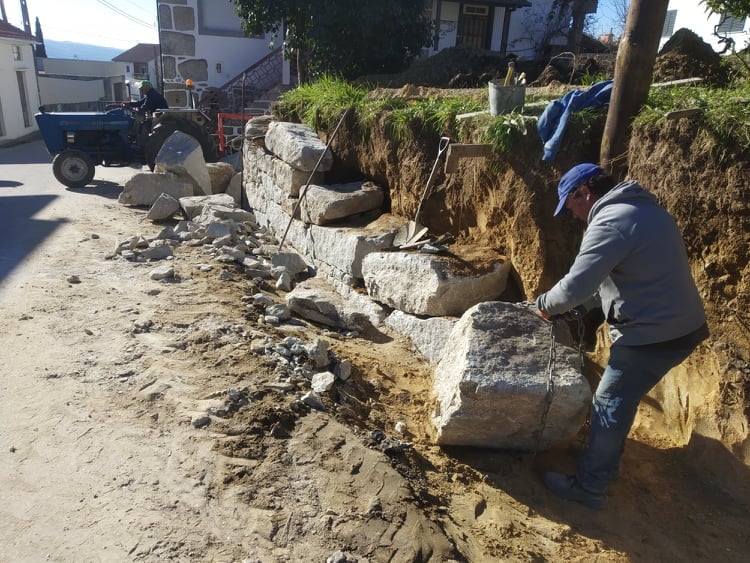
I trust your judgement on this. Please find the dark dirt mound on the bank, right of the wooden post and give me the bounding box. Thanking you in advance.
[653,28,729,87]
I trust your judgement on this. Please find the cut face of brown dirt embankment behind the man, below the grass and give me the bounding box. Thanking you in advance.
[333,94,750,486]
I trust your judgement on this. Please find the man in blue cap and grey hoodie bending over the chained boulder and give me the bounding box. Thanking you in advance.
[536,163,708,509]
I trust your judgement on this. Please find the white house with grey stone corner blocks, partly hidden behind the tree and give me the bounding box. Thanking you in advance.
[157,0,597,112]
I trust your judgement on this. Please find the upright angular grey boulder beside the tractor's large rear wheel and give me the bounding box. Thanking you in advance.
[154,131,211,195]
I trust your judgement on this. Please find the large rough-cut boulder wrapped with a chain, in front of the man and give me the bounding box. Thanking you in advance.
[432,301,591,450]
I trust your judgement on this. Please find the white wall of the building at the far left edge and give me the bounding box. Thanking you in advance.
[0,20,40,144]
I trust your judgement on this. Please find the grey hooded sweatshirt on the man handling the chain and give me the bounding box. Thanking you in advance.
[537,181,706,346]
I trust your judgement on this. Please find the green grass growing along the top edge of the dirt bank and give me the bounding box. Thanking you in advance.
[276,76,750,153]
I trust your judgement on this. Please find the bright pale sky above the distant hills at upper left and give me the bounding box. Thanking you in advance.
[4,0,159,50]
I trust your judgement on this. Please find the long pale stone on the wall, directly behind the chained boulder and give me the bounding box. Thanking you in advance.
[362,252,511,317]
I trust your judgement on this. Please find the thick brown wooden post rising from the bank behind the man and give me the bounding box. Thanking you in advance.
[599,0,669,179]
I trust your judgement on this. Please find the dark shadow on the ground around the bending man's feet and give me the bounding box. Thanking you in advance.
[446,436,750,562]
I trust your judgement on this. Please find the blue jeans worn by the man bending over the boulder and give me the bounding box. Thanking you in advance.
[576,345,695,494]
